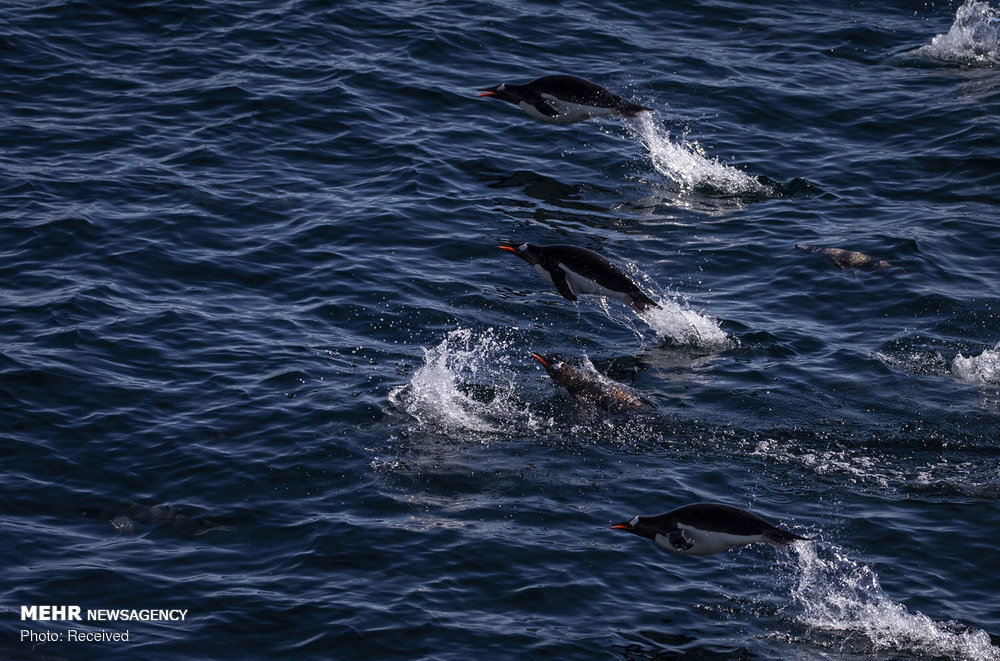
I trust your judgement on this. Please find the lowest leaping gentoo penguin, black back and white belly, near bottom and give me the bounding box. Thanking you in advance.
[611,503,808,555]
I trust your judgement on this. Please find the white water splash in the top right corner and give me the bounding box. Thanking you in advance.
[914,0,1000,66]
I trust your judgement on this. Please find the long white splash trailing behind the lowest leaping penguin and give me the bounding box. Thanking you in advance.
[791,543,1000,661]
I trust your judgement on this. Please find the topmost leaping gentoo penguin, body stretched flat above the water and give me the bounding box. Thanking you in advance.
[479,75,650,124]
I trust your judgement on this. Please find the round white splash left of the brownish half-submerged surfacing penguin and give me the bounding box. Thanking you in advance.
[389,328,532,433]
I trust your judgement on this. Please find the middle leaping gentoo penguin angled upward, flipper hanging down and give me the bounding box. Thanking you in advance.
[498,241,660,312]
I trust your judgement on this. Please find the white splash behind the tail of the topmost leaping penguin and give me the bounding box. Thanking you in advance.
[625,113,772,195]
